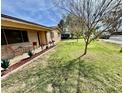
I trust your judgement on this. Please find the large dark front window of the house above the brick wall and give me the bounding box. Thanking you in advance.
[1,29,28,45]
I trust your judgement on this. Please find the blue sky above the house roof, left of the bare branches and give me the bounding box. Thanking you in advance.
[1,0,64,26]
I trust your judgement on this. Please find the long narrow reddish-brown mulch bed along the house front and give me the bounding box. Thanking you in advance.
[1,46,54,76]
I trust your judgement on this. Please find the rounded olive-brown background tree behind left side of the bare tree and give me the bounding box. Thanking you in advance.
[58,14,83,41]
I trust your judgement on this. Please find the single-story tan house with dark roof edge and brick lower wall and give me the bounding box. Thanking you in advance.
[1,14,61,58]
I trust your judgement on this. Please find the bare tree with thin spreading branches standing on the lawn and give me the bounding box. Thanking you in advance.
[55,0,121,58]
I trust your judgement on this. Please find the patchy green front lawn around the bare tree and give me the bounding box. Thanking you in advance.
[1,40,122,93]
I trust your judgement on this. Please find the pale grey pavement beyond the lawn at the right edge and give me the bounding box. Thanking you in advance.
[102,35,122,45]
